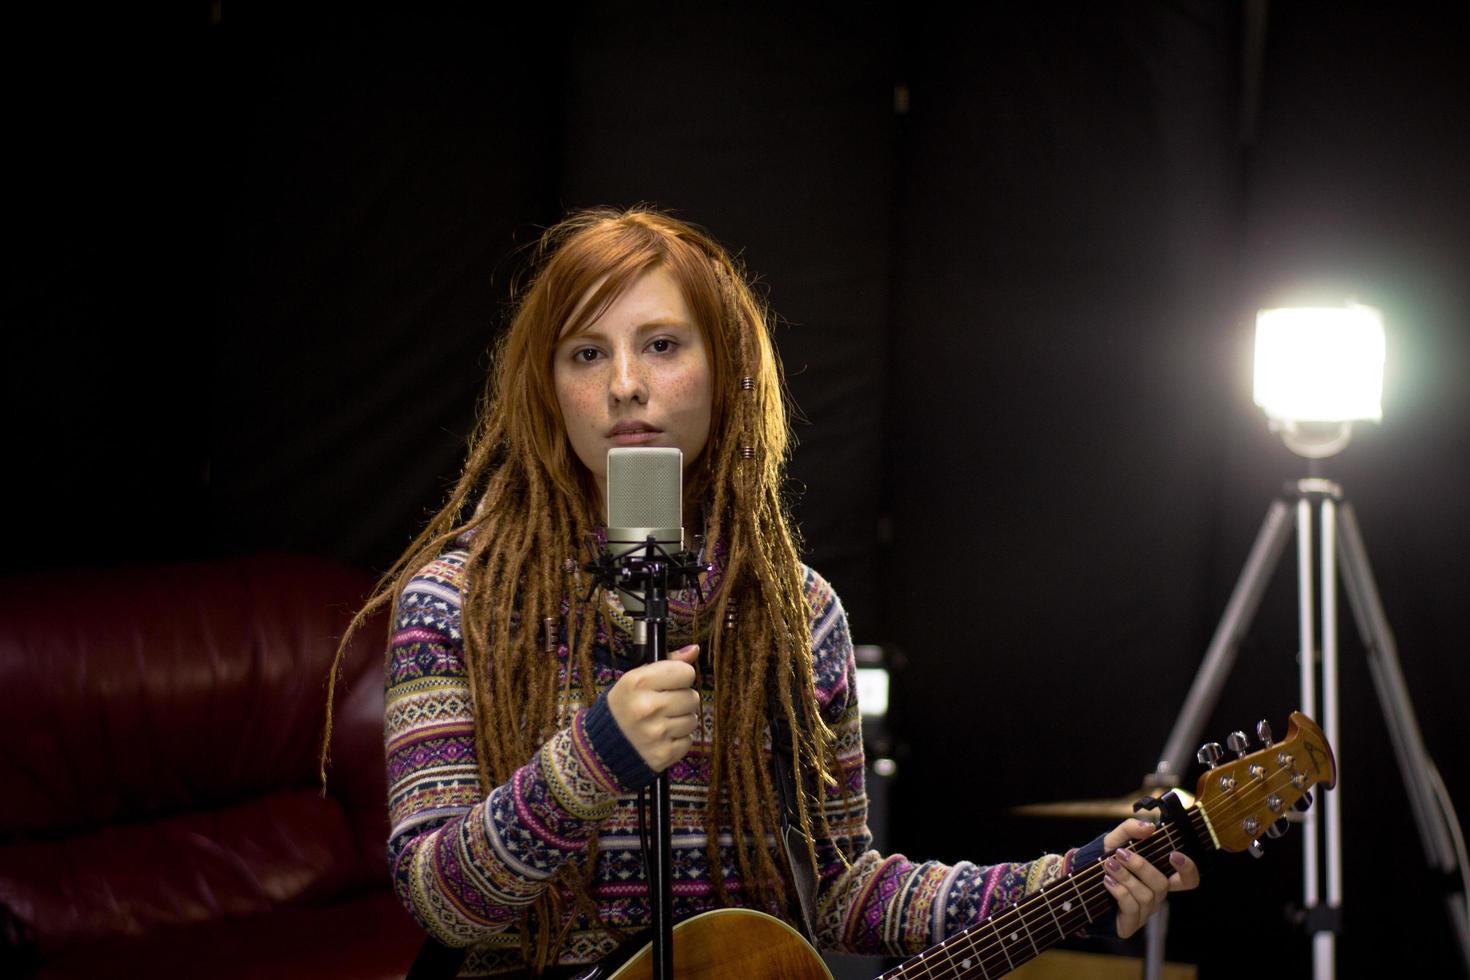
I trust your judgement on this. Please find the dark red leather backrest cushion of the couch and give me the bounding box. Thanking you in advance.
[0,557,384,840]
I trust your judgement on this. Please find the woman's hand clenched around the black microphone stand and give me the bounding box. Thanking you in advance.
[607,644,700,773]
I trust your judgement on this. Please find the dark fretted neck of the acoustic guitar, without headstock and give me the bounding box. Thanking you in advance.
[879,807,1208,980]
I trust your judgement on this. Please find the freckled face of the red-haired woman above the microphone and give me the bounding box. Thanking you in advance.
[551,269,710,500]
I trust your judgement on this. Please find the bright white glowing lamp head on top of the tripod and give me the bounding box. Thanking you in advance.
[1255,303,1383,422]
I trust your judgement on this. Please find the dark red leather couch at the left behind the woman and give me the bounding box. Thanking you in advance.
[0,557,422,979]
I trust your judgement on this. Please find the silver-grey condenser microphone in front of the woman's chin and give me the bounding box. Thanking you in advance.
[607,447,684,616]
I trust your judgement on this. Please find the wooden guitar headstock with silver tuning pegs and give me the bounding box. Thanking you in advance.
[1195,711,1338,851]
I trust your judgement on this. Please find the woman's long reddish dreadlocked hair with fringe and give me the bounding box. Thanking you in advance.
[322,209,835,970]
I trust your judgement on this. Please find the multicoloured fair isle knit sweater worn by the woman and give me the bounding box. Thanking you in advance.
[385,551,1094,976]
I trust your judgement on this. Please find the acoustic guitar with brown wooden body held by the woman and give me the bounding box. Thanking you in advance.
[578,711,1338,980]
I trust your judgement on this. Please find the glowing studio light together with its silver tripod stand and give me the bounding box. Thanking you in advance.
[1145,303,1470,980]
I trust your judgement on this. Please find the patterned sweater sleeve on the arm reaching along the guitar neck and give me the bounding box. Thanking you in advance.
[807,570,1105,956]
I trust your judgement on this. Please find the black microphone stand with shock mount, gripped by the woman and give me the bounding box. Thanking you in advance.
[587,535,709,980]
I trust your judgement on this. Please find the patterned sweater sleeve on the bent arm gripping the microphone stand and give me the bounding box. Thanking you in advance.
[384,552,653,946]
